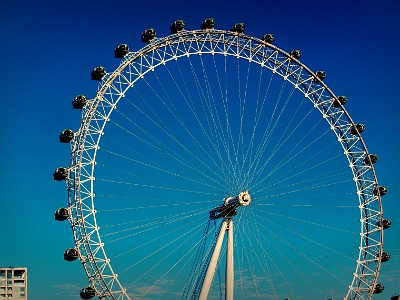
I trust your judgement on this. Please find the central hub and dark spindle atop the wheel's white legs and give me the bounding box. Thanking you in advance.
[210,191,251,220]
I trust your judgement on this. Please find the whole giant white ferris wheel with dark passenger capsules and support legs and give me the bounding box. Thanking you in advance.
[53,19,391,299]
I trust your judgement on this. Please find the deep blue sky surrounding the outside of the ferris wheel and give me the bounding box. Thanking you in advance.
[0,1,400,300]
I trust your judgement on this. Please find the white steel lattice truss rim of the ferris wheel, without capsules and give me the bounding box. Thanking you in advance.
[67,30,383,299]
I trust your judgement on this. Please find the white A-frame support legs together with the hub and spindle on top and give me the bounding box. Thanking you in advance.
[198,191,251,300]
